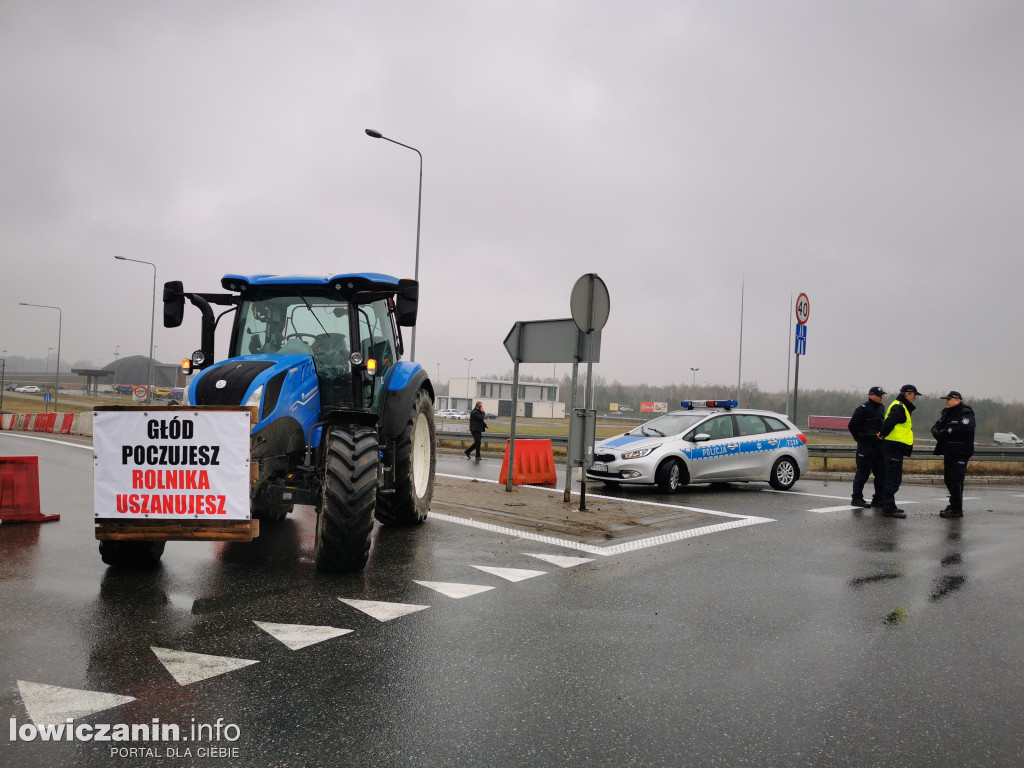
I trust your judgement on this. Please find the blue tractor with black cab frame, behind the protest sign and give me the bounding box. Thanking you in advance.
[156,273,436,571]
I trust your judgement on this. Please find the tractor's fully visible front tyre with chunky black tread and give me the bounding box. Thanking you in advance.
[313,425,380,571]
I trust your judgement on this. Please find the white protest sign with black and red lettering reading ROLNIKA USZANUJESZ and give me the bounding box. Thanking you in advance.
[92,410,251,521]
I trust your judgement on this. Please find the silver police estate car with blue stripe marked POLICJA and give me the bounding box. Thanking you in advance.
[587,400,808,493]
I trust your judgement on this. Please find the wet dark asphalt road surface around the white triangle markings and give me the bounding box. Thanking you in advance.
[0,434,1024,766]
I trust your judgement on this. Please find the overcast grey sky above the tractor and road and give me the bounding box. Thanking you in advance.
[0,0,1024,400]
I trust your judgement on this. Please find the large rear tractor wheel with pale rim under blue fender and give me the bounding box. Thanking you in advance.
[375,389,437,525]
